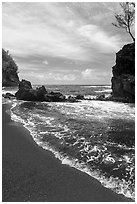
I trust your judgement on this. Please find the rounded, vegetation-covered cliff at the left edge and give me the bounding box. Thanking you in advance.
[2,49,19,86]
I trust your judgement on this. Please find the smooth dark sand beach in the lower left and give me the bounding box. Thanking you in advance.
[2,105,132,202]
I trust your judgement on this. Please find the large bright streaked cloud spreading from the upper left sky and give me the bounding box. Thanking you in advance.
[3,3,122,61]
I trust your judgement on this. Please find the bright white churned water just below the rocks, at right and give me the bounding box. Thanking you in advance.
[54,100,135,121]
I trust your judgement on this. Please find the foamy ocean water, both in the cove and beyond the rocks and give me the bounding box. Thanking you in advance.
[3,85,135,200]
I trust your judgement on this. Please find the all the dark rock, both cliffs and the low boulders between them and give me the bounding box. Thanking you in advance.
[2,43,135,103]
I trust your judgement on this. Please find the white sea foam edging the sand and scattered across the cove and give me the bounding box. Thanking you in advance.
[11,102,135,200]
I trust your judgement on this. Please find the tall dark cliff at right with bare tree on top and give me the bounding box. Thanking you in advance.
[111,43,135,102]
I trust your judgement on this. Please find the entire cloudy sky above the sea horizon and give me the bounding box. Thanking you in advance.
[2,2,134,84]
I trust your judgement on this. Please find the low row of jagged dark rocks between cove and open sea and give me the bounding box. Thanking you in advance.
[2,79,134,103]
